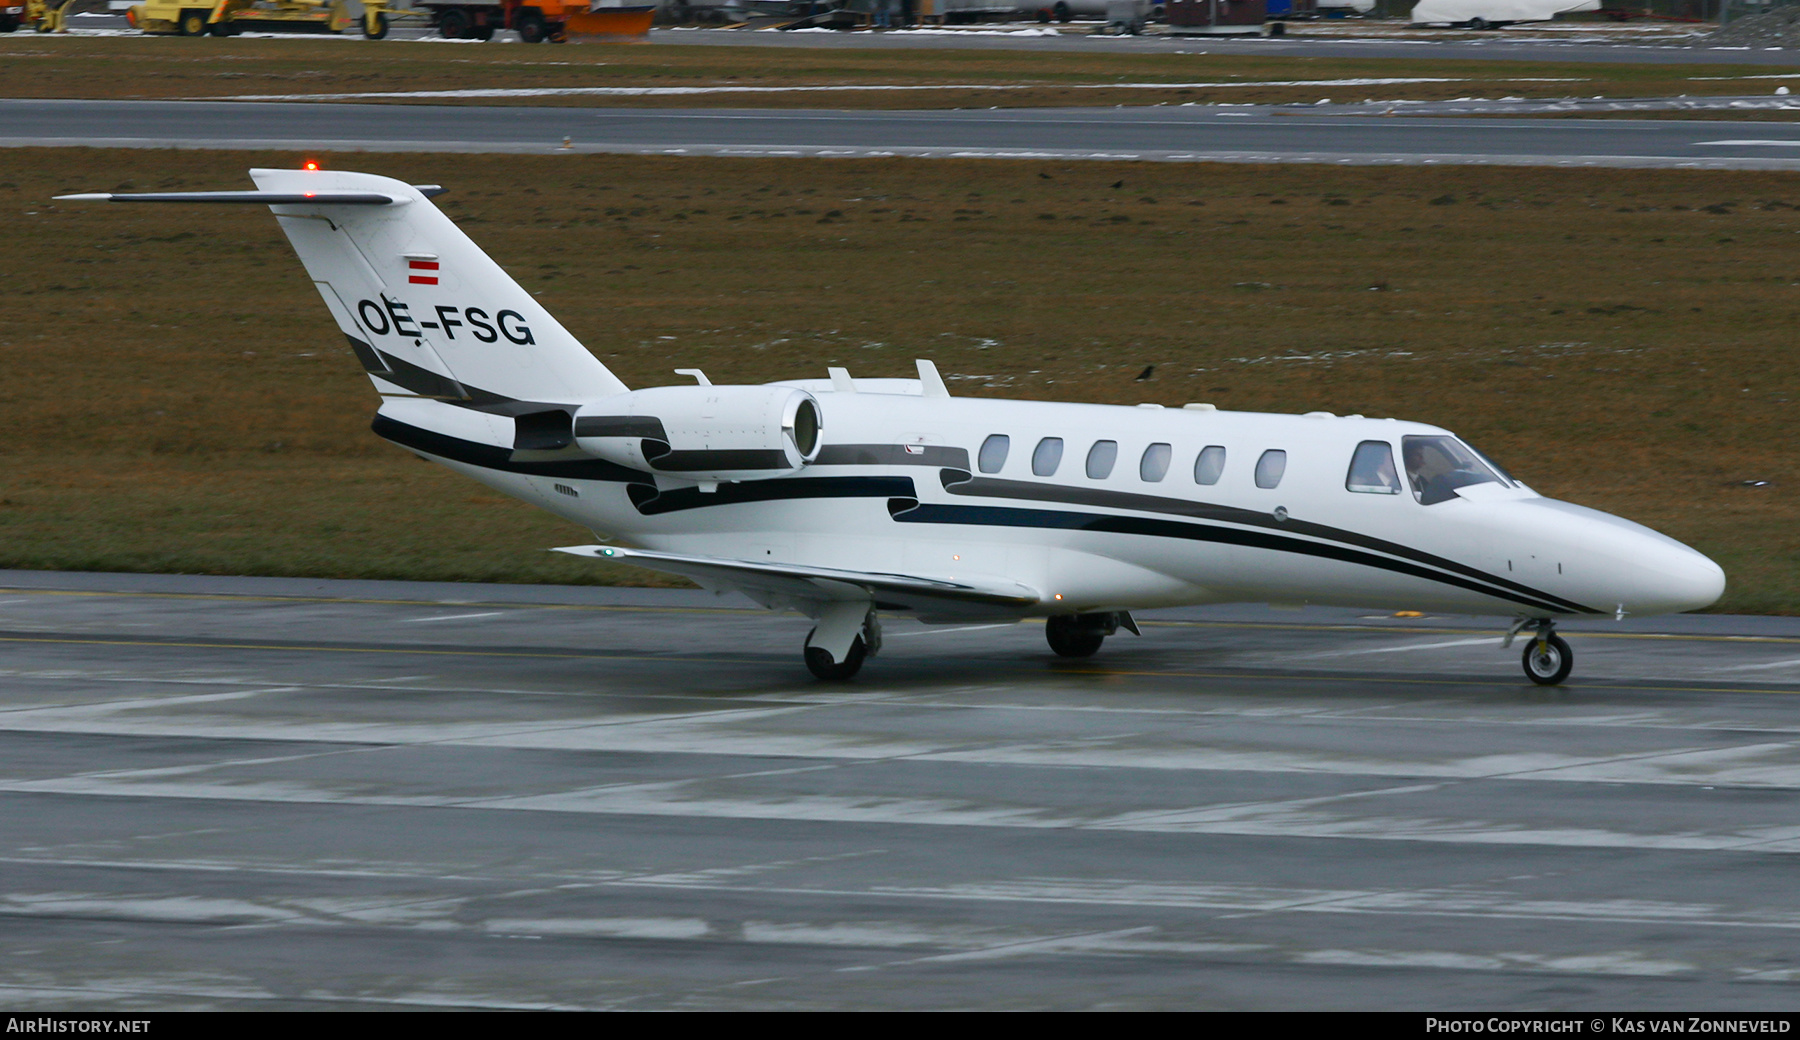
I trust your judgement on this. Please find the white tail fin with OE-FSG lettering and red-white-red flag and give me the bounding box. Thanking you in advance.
[250,169,626,403]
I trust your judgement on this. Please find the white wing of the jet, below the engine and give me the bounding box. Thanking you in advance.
[554,545,1040,615]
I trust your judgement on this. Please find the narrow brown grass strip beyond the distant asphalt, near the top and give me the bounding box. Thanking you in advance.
[0,32,1800,108]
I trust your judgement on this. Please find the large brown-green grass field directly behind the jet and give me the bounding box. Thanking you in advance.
[0,149,1800,612]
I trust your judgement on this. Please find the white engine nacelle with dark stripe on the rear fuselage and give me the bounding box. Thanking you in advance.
[574,387,819,484]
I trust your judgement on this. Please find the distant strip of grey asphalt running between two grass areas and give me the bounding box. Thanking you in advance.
[17,101,1800,169]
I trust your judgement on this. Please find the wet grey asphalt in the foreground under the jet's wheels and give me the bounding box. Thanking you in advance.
[10,572,1800,1011]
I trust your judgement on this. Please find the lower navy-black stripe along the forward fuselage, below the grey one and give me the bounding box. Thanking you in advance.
[889,498,1598,614]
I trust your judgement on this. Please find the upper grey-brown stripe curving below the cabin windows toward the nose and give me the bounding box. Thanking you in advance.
[940,470,1604,614]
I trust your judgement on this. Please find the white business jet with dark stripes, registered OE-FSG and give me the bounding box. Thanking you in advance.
[63,164,1724,684]
